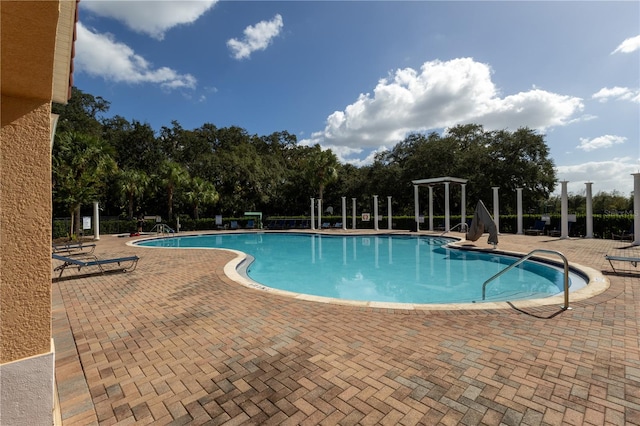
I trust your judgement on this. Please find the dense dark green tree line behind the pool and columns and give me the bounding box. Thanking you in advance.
[52,87,632,235]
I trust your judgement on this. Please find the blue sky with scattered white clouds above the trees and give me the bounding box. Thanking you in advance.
[74,0,640,195]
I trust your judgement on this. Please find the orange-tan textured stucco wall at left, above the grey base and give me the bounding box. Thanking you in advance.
[0,95,51,364]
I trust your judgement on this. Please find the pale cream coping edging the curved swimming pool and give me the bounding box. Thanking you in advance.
[134,230,611,311]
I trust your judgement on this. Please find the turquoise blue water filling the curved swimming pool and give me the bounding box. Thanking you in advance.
[138,233,584,304]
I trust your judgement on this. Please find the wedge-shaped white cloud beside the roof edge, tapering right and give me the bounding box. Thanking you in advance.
[75,22,196,90]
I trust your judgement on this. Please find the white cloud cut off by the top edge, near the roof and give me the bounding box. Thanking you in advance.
[80,0,218,40]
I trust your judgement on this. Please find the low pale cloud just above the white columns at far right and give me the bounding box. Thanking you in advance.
[554,157,640,196]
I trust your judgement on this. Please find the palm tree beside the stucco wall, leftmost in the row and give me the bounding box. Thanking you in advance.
[52,132,117,235]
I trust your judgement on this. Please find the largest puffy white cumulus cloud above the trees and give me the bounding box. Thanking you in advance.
[303,58,584,161]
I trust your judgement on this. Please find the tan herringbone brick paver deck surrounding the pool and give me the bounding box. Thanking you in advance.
[53,230,640,425]
